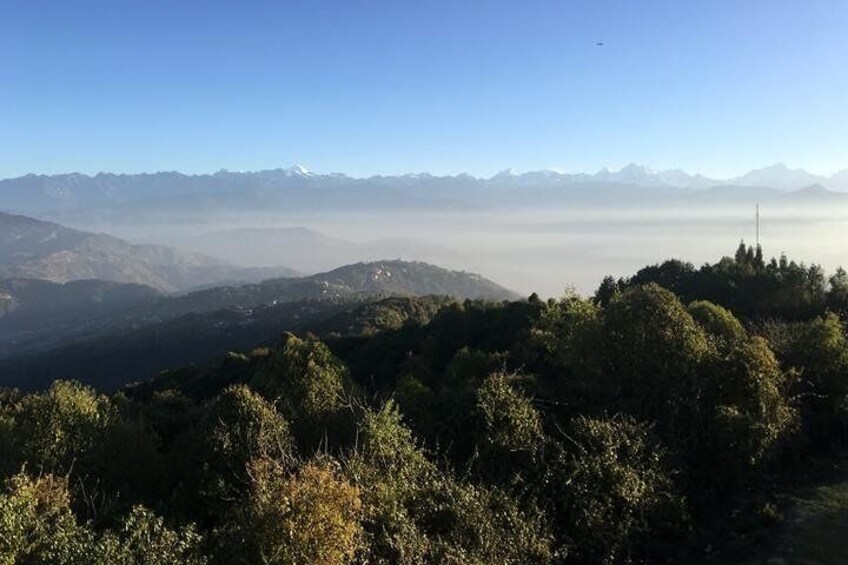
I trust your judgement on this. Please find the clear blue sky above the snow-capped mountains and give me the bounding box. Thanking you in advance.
[0,0,848,177]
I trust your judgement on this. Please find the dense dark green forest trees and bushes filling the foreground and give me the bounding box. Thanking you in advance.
[0,246,848,564]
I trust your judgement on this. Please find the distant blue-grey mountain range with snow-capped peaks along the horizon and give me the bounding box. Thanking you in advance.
[0,163,848,213]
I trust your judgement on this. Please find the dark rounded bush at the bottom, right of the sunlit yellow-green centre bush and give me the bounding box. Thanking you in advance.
[546,417,687,564]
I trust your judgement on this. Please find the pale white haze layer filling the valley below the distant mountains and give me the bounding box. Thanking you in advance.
[68,203,848,296]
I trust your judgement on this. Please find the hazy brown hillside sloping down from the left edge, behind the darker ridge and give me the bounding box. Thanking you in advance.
[0,212,298,292]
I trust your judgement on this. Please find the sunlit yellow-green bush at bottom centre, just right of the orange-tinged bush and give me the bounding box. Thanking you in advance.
[347,403,551,564]
